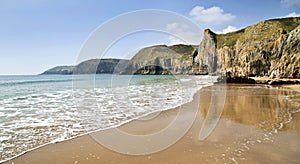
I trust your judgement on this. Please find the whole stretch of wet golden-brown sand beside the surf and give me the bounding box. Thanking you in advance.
[2,84,300,164]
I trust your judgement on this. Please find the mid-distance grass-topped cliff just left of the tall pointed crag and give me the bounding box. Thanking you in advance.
[126,45,197,74]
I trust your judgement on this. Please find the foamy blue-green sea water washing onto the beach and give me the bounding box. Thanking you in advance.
[0,74,216,161]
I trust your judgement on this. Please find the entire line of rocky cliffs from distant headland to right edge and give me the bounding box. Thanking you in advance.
[43,17,300,78]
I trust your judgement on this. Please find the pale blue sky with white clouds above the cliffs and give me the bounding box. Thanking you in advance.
[0,0,300,75]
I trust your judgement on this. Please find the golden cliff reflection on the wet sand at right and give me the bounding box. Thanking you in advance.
[200,85,300,134]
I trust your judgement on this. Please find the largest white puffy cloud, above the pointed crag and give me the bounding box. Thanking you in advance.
[189,6,236,24]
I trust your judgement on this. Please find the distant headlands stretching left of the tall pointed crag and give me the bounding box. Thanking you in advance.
[42,44,198,75]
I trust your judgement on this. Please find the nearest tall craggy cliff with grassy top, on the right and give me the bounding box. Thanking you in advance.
[194,17,300,78]
